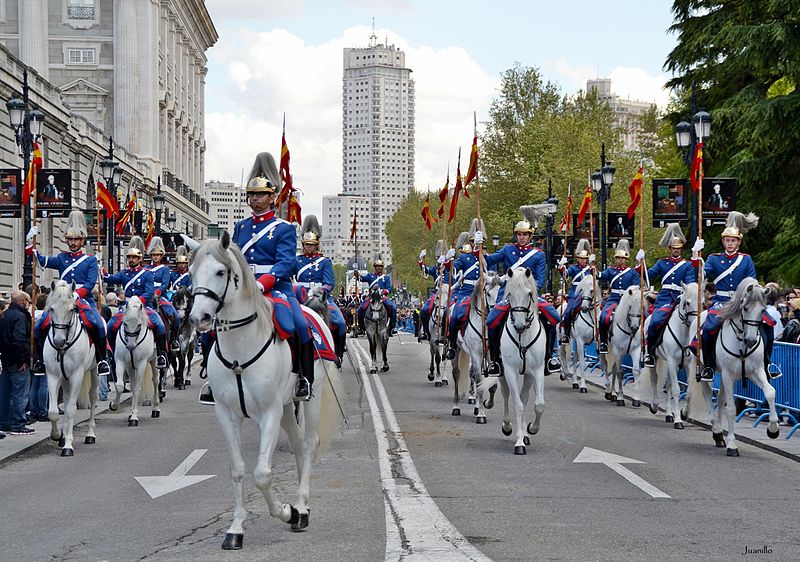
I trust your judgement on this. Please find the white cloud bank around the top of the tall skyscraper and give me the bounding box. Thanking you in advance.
[206,25,499,218]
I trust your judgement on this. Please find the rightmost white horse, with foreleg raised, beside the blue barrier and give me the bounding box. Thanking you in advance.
[688,278,780,457]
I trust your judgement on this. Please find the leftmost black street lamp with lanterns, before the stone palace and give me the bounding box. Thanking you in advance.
[6,68,44,287]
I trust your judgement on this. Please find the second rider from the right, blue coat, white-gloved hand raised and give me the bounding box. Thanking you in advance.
[636,222,697,367]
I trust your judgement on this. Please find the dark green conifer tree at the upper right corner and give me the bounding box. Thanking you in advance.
[665,0,800,284]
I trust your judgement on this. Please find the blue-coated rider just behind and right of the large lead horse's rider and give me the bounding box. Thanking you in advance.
[295,215,347,359]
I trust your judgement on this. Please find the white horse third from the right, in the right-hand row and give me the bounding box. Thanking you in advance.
[600,286,642,406]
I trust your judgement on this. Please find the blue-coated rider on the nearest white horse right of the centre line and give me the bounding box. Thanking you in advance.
[486,210,561,377]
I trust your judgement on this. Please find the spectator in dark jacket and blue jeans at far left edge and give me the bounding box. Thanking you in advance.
[0,290,36,435]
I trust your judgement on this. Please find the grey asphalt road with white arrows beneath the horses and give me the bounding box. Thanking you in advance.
[0,335,800,561]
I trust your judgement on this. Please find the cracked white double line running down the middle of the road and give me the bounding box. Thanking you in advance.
[351,340,491,561]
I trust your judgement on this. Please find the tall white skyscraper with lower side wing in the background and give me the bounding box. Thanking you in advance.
[322,33,414,263]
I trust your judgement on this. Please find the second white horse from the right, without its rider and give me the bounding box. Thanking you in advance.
[639,283,698,429]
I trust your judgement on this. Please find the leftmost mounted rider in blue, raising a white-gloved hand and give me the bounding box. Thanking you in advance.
[25,211,110,375]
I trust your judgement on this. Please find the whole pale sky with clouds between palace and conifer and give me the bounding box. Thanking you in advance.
[206,0,676,218]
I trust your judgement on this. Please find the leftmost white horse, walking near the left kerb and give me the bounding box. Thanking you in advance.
[43,281,100,457]
